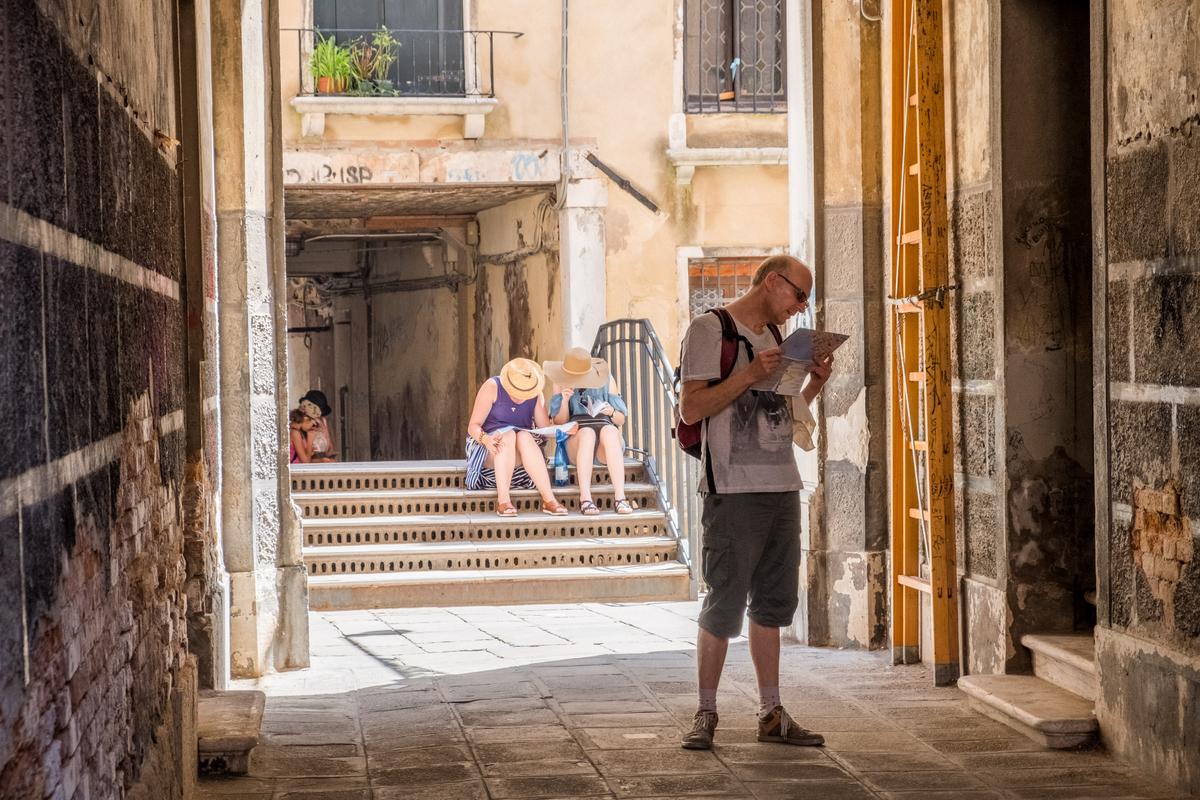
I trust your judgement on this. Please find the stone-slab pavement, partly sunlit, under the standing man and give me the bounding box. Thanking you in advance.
[200,602,1180,800]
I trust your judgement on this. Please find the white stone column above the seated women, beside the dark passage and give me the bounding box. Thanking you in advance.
[558,178,608,349]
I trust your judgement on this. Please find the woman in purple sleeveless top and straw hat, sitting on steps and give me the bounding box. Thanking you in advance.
[467,359,566,517]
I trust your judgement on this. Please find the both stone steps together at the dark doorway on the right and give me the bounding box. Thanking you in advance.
[959,633,1099,750]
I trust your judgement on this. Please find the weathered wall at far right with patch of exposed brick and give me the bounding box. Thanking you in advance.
[1093,0,1200,792]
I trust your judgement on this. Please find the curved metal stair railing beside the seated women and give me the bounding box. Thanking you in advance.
[592,319,700,596]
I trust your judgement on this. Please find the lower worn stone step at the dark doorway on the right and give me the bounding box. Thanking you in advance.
[959,675,1099,750]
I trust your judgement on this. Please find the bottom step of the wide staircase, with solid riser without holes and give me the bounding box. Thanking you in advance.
[308,561,689,610]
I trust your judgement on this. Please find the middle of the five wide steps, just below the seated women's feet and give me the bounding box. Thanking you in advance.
[301,509,670,548]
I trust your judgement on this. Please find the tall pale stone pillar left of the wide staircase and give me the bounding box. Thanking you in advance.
[212,0,308,678]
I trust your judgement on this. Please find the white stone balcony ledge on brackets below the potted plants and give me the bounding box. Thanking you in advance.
[292,95,499,139]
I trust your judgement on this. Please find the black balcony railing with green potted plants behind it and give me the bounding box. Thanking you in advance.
[281,28,522,97]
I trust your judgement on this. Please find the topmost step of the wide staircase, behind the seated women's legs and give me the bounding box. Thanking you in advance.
[290,458,646,492]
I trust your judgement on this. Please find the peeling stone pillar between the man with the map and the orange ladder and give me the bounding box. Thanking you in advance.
[793,0,888,649]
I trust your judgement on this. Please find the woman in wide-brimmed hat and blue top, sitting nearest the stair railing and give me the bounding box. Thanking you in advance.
[542,348,634,516]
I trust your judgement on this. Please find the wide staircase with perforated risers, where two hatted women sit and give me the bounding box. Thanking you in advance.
[290,461,690,609]
